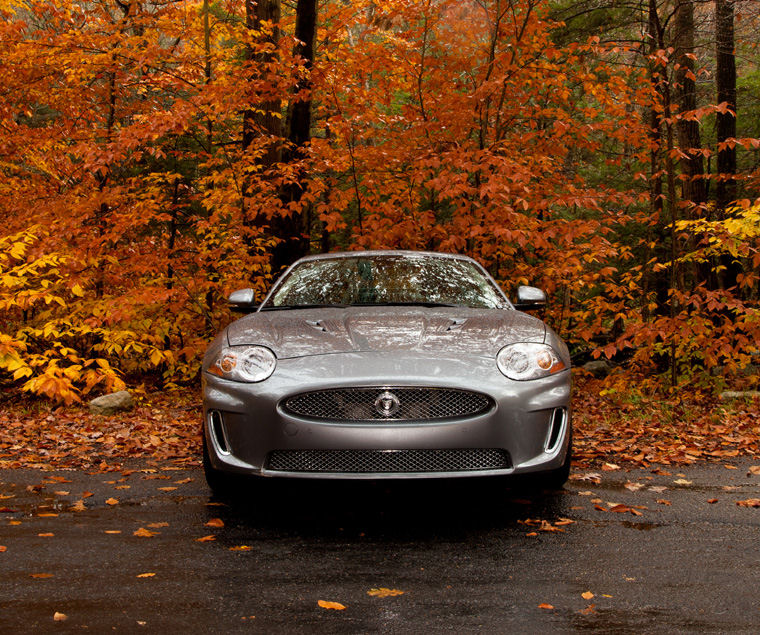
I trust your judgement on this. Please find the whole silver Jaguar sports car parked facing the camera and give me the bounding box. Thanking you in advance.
[203,251,572,493]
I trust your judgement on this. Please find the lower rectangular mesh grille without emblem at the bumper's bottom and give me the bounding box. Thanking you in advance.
[267,448,512,474]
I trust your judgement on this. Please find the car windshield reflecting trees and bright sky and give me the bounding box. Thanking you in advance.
[262,255,508,310]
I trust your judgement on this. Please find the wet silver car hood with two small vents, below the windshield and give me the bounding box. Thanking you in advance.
[227,306,546,359]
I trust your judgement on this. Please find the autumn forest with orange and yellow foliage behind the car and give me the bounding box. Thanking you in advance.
[0,0,760,418]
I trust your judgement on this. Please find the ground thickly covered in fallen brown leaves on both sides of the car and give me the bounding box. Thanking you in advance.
[0,377,760,471]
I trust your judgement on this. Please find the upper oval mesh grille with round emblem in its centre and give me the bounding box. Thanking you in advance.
[282,386,493,421]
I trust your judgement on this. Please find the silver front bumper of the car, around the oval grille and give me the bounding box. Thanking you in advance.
[203,352,571,479]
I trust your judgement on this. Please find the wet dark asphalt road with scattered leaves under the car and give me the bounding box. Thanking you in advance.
[0,460,760,633]
